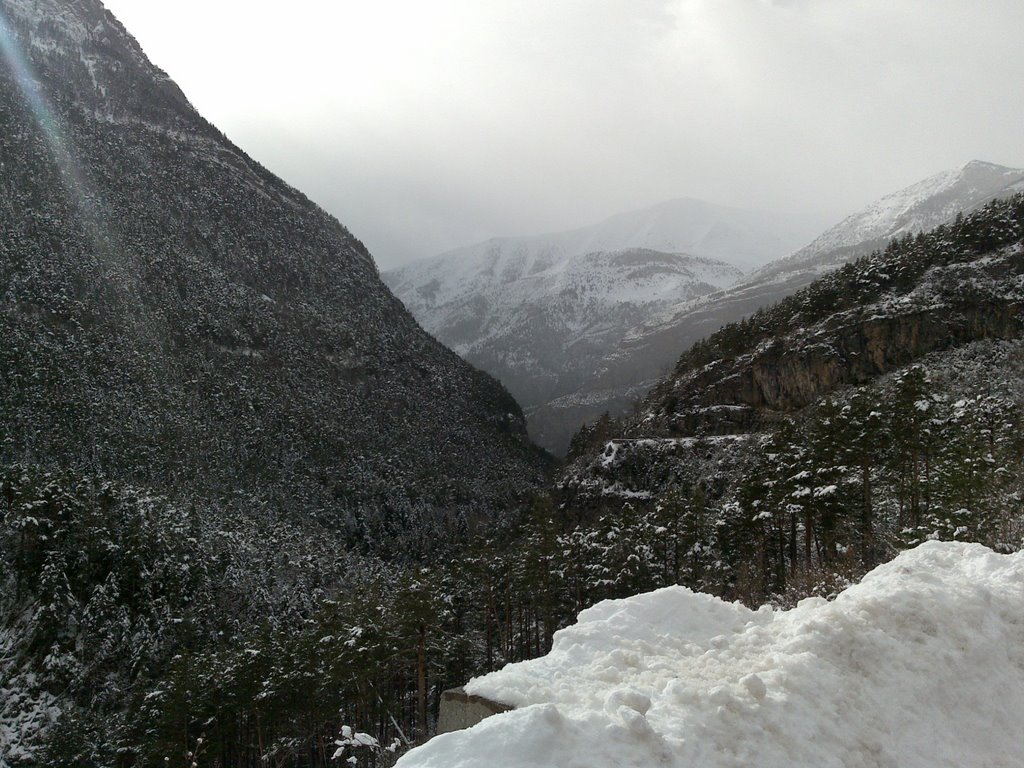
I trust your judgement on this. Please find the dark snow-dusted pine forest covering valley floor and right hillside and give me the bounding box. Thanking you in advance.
[8,198,1024,765]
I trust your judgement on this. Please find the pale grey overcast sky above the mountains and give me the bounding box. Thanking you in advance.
[97,0,1024,269]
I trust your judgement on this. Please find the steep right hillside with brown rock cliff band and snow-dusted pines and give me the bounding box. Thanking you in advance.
[559,196,1024,602]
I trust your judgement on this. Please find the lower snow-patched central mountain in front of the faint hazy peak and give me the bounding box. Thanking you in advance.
[389,249,740,434]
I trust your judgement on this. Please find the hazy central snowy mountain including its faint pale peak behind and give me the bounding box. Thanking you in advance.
[384,200,813,452]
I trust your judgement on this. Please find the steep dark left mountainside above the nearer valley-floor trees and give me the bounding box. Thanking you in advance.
[0,0,546,530]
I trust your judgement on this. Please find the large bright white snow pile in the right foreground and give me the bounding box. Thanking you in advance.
[398,542,1024,768]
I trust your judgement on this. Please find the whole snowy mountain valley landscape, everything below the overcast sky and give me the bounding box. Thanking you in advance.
[0,0,1024,768]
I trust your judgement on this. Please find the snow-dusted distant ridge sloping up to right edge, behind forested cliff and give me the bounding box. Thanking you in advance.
[557,161,1024,448]
